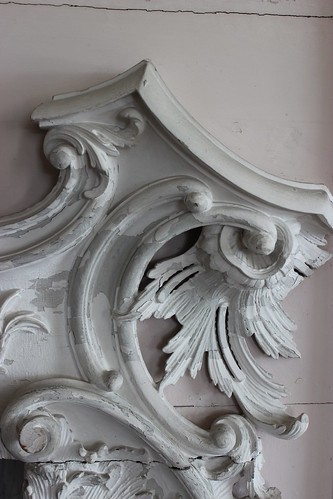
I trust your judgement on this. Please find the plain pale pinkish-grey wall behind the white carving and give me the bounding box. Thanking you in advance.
[0,0,333,499]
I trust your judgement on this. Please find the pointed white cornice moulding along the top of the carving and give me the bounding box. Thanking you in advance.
[32,61,333,227]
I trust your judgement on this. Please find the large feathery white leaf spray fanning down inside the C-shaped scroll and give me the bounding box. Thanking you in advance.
[129,211,330,438]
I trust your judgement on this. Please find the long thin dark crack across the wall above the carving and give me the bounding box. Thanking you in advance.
[0,1,333,19]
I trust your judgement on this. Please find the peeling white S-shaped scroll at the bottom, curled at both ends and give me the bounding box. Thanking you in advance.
[1,378,278,499]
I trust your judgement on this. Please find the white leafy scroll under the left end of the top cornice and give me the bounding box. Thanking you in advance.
[0,107,145,270]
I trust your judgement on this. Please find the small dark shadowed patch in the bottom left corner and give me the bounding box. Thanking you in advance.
[0,459,24,499]
